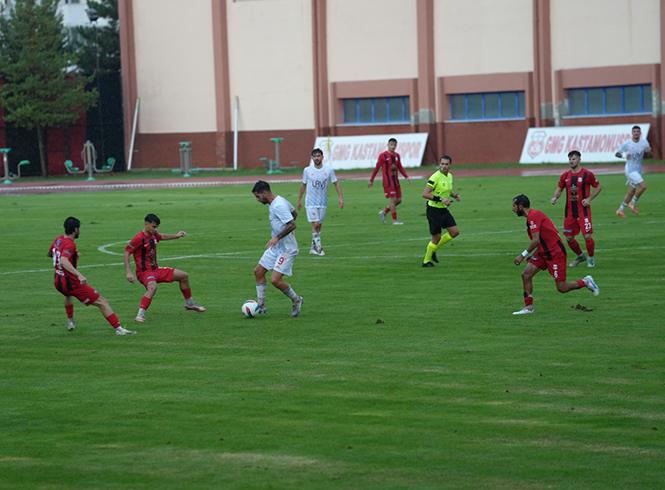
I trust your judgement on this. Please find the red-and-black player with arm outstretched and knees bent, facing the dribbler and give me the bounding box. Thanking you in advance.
[123,213,206,322]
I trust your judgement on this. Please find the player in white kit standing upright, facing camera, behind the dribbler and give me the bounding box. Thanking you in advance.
[298,148,344,255]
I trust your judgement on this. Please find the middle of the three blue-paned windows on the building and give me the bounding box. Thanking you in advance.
[450,91,525,120]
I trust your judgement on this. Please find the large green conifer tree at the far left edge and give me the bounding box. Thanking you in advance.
[0,0,97,177]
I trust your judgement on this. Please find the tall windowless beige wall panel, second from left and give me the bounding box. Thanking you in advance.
[227,0,314,131]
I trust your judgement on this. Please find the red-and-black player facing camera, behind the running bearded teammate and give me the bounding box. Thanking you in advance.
[550,150,603,267]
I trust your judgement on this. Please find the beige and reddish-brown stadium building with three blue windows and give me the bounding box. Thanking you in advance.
[119,0,665,168]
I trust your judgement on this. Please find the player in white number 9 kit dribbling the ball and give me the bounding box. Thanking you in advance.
[252,180,304,316]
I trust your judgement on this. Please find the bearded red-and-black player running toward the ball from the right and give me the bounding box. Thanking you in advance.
[513,194,599,315]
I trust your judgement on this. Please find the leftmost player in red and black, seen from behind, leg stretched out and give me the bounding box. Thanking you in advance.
[46,216,136,335]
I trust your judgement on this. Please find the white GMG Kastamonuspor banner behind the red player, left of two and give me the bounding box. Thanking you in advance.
[310,133,428,170]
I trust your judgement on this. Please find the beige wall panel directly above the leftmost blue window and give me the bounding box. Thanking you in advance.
[327,0,418,82]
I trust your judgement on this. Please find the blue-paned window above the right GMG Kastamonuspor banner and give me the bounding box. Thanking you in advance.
[568,84,653,116]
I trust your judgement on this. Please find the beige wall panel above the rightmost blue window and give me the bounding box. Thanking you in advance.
[551,0,660,70]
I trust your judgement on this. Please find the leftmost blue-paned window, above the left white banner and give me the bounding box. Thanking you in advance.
[343,97,411,124]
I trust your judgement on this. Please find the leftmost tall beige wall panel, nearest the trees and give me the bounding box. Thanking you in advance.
[133,0,216,133]
